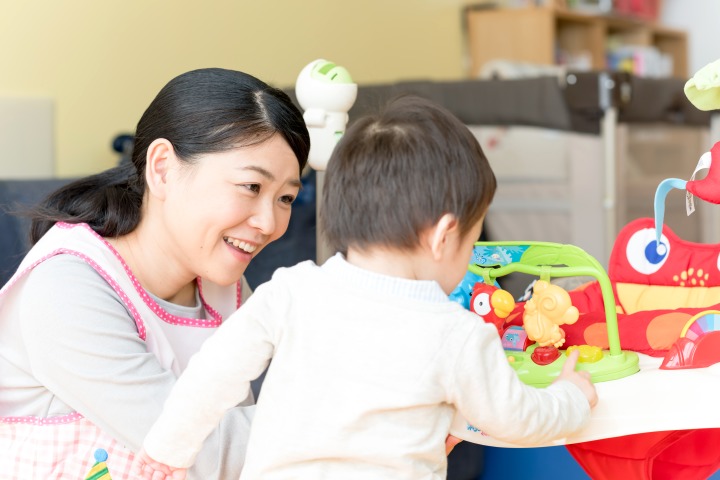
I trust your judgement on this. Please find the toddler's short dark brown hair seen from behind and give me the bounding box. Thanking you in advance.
[320,91,496,254]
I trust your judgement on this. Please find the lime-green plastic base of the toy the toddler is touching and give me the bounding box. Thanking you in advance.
[505,344,640,387]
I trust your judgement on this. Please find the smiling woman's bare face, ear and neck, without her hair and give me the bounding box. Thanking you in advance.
[109,135,300,305]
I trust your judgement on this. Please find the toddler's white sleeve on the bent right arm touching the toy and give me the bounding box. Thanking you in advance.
[449,323,590,446]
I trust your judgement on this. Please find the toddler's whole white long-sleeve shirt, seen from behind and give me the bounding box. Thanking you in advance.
[144,255,590,480]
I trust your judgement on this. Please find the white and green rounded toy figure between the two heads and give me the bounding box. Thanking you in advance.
[295,59,357,171]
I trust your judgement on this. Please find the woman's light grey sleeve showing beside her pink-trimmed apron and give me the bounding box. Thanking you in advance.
[20,255,254,479]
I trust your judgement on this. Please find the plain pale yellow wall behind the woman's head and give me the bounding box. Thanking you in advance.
[0,0,472,176]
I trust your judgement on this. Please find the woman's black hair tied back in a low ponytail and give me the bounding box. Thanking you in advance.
[29,68,310,244]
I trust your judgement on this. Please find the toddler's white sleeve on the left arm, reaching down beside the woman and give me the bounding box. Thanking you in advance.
[143,278,276,468]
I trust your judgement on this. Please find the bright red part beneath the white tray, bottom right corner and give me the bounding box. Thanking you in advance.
[567,429,720,480]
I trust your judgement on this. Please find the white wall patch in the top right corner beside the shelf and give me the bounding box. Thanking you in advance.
[661,0,720,75]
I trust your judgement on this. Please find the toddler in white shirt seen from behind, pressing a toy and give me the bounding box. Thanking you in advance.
[135,96,597,480]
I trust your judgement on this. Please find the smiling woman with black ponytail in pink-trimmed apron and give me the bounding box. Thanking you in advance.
[0,69,310,479]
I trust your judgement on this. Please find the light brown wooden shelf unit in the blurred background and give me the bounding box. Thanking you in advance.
[464,6,688,78]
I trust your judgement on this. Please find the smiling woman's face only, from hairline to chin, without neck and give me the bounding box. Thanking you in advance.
[164,135,300,285]
